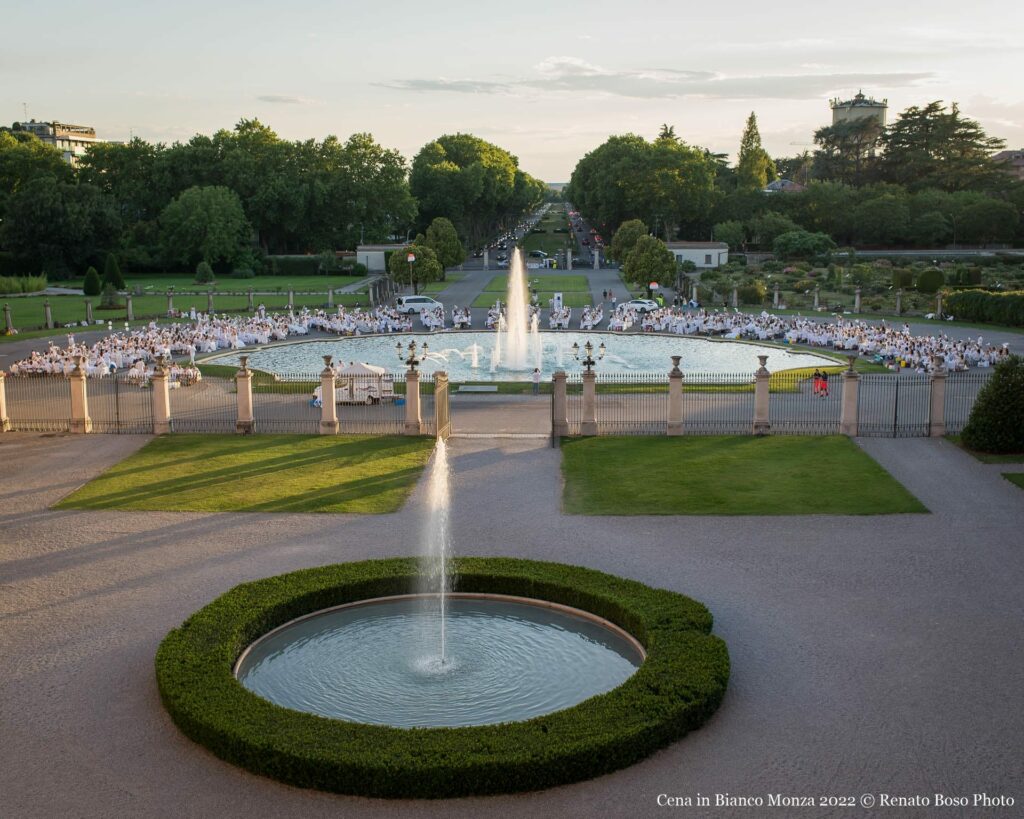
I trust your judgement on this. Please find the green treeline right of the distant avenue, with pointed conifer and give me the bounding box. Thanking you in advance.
[563,101,1024,251]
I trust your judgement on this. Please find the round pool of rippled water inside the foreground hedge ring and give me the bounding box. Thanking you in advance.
[236,595,644,728]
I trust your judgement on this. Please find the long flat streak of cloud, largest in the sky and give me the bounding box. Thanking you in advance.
[383,56,935,99]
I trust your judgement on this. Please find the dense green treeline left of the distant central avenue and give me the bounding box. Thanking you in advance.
[0,120,547,278]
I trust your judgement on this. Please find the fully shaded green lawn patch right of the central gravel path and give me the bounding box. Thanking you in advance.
[562,435,928,511]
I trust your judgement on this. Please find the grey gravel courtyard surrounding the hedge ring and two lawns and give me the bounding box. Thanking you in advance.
[0,433,1024,819]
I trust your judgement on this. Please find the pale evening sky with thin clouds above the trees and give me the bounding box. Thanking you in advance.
[0,0,1024,181]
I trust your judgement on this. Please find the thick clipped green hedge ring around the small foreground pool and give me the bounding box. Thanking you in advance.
[157,558,729,798]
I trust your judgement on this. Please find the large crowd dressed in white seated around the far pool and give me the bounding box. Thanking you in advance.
[9,305,1009,385]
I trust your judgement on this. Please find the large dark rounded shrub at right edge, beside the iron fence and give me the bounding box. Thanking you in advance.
[961,355,1024,455]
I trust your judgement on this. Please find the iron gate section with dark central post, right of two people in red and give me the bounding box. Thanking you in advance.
[857,373,931,438]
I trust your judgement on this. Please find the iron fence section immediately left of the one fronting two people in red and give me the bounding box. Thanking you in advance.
[683,373,754,435]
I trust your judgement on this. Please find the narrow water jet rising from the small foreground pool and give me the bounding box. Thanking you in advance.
[422,438,452,665]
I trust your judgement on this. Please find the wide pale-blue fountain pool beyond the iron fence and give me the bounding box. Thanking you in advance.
[206,331,837,382]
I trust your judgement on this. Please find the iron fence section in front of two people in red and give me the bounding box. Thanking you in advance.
[768,370,843,435]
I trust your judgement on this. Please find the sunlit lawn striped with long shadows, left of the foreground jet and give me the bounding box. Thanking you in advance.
[56,434,433,514]
